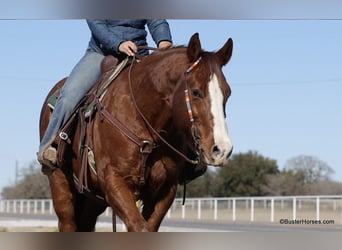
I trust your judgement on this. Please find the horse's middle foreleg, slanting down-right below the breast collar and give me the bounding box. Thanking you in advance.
[104,166,148,232]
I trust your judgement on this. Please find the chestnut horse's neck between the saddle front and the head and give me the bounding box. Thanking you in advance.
[133,49,187,130]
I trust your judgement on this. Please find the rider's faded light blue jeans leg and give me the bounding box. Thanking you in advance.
[39,51,104,149]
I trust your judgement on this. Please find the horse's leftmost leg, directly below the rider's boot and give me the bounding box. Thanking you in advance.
[45,168,76,232]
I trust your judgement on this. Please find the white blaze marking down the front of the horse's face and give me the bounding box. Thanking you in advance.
[209,74,232,160]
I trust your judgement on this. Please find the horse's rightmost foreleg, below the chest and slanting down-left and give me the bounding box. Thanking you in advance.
[142,185,177,232]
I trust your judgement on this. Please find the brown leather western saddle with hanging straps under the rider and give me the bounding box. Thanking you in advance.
[47,55,131,193]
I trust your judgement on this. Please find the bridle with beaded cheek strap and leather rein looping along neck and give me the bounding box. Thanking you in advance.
[128,57,201,165]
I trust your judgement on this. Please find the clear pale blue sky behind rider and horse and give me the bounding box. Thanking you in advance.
[0,20,342,189]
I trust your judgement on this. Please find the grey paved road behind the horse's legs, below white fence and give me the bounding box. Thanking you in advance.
[0,213,342,232]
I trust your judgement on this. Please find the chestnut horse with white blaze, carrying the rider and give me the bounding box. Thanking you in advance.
[40,33,233,232]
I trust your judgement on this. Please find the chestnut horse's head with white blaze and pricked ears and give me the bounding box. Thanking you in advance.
[172,33,233,166]
